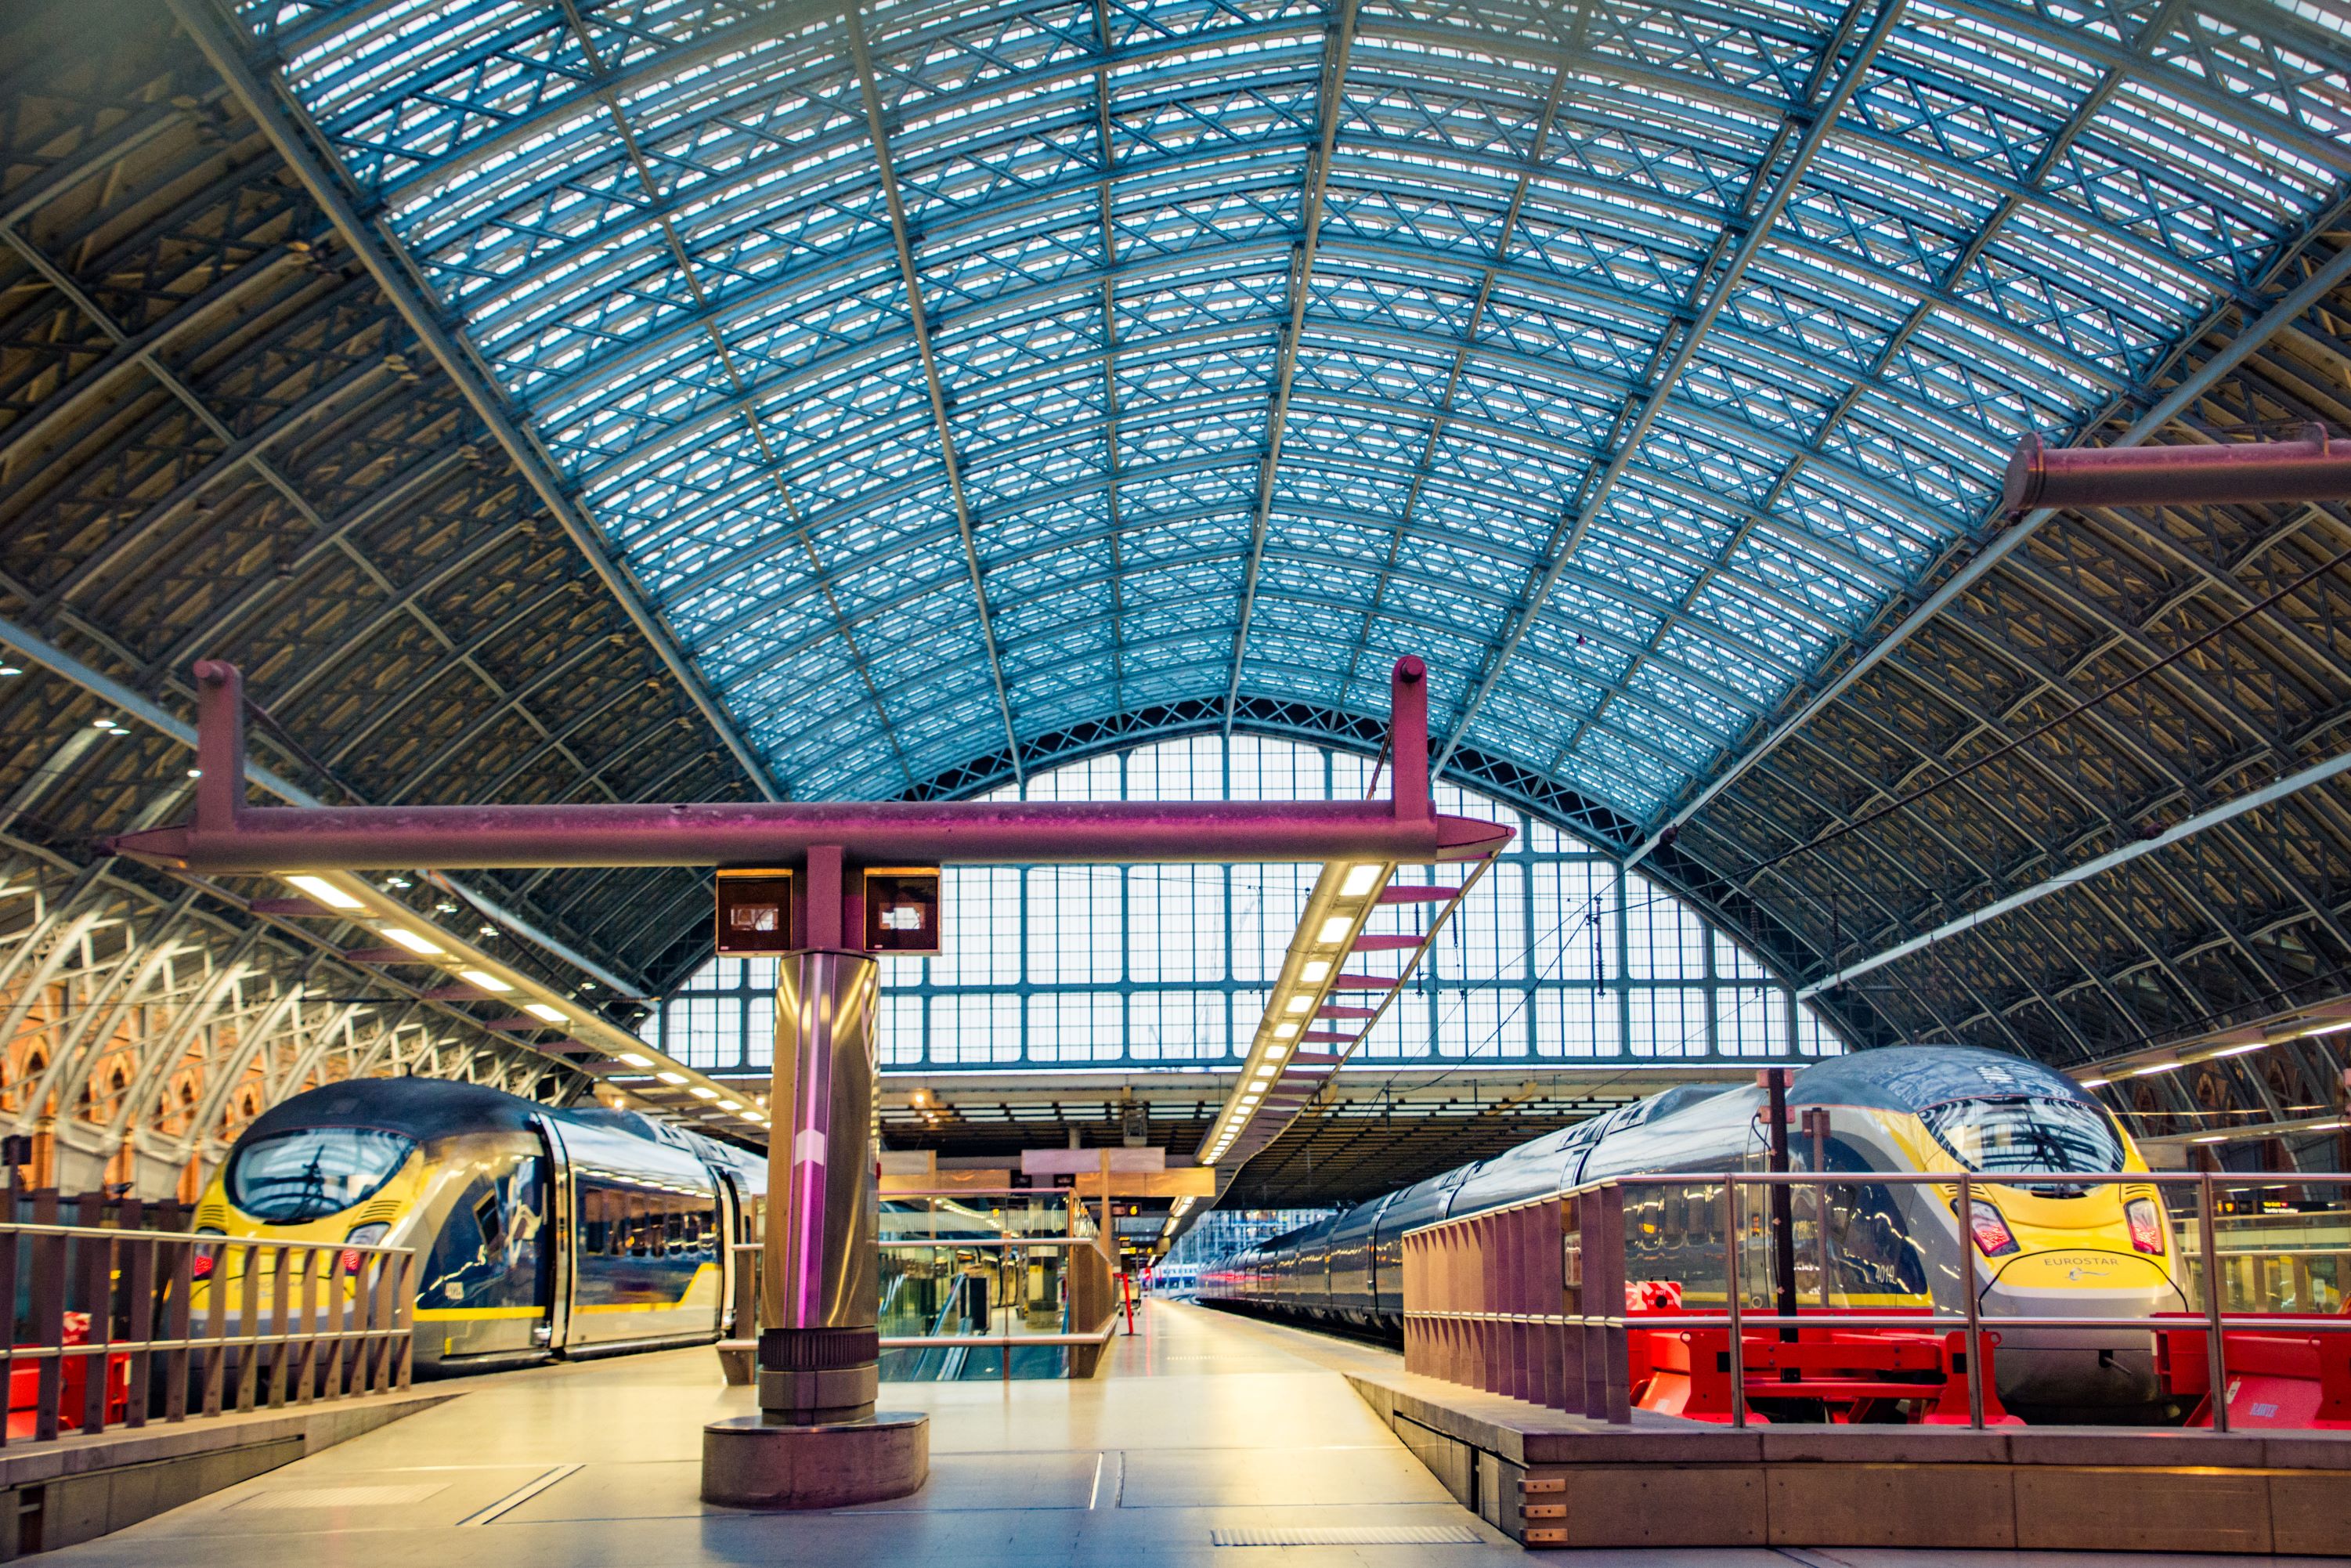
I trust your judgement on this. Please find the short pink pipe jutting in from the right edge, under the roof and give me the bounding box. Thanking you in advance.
[2001,425,2351,512]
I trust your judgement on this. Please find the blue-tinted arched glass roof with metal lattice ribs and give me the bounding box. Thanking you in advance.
[224,0,2351,823]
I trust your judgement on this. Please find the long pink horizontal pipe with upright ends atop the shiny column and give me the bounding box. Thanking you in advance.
[110,658,1509,875]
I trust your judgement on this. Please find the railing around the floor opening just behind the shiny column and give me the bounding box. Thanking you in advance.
[722,1187,1119,1382]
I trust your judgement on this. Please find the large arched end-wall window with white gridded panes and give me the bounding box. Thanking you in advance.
[645,735,1841,1072]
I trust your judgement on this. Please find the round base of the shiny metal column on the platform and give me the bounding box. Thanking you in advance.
[703,1411,931,1509]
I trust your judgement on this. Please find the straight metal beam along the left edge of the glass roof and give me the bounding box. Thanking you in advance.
[167,0,785,800]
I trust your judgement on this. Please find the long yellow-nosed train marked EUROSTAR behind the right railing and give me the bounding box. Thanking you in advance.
[1199,1046,2187,1413]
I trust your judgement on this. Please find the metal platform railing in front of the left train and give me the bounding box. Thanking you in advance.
[0,1223,416,1441]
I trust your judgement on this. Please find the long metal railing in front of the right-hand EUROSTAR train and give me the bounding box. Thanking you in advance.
[1403,1171,2351,1432]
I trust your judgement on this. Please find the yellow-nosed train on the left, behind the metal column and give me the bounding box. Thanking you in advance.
[190,1079,767,1375]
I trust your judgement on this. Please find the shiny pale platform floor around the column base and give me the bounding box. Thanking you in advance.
[40,1302,2320,1568]
